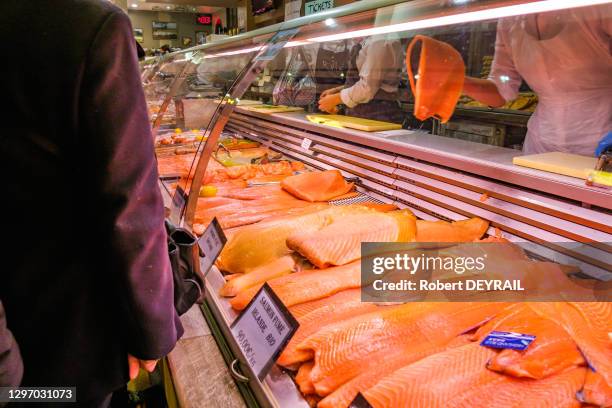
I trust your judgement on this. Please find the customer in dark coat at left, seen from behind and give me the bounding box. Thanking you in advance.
[0,0,182,405]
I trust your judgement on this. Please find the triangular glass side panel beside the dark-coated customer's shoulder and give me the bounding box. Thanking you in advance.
[143,35,280,223]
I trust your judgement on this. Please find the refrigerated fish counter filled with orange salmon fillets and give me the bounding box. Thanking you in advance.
[159,135,612,407]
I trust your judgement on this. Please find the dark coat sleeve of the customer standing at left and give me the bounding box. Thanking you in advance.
[78,12,183,359]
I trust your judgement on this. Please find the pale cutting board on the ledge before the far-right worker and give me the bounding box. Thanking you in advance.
[512,152,597,179]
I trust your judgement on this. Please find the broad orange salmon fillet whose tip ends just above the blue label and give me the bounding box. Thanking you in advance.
[297,302,506,396]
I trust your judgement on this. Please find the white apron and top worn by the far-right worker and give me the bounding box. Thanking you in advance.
[490,5,612,156]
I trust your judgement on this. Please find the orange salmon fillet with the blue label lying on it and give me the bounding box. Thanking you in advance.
[474,303,585,379]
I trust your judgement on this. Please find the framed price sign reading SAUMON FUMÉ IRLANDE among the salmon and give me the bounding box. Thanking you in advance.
[231,283,299,381]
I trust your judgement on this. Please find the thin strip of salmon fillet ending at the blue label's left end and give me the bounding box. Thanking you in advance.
[317,334,471,408]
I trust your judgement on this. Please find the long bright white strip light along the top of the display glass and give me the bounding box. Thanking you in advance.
[308,0,611,42]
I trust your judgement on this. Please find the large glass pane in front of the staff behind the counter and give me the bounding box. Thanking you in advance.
[256,0,612,161]
